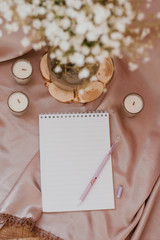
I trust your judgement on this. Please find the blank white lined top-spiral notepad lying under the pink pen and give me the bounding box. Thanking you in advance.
[39,112,114,212]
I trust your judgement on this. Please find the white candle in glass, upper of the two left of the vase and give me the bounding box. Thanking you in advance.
[12,59,33,84]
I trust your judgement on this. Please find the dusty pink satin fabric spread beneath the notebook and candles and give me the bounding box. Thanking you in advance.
[0,46,160,240]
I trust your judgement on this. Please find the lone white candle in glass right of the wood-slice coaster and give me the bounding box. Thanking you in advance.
[123,93,144,117]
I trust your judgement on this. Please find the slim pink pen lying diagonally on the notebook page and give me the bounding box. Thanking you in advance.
[78,138,119,205]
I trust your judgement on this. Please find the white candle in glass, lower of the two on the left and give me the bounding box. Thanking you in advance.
[7,92,29,116]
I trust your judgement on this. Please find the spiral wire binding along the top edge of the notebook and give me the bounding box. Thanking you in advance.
[39,111,108,118]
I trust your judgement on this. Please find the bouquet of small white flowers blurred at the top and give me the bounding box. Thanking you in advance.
[0,0,160,80]
